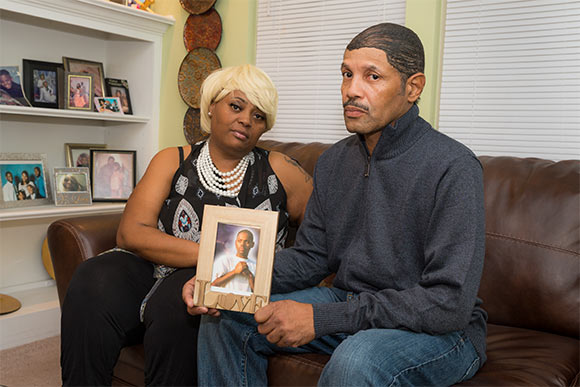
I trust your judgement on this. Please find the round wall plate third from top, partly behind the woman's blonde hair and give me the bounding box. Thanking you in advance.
[177,47,221,109]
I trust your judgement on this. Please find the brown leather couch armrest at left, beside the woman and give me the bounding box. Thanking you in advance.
[47,213,122,306]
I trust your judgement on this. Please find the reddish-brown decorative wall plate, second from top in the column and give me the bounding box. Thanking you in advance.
[183,9,222,51]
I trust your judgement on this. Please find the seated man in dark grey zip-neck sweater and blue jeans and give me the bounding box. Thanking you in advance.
[183,23,486,386]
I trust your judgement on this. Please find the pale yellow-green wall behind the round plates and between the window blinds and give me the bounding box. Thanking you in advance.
[152,0,446,149]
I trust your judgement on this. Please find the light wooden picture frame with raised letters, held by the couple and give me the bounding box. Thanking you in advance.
[193,205,278,314]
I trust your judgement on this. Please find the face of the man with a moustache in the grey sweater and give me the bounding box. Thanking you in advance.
[340,48,412,136]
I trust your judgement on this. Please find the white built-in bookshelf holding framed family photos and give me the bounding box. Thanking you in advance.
[0,0,174,348]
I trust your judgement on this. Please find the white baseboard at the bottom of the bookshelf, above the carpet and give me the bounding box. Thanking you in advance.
[0,284,60,350]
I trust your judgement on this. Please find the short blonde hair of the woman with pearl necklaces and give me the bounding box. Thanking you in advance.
[200,64,278,133]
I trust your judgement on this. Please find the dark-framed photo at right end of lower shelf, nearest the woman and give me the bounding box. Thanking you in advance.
[90,149,137,202]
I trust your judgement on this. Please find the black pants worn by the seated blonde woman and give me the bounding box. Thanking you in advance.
[61,252,199,386]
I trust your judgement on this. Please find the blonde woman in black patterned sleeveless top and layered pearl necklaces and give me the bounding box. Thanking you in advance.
[61,65,312,386]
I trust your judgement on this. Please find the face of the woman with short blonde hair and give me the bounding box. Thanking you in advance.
[209,90,266,157]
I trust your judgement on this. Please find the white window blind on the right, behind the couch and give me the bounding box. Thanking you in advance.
[439,0,580,161]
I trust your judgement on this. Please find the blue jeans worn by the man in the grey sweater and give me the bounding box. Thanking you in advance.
[198,287,480,386]
